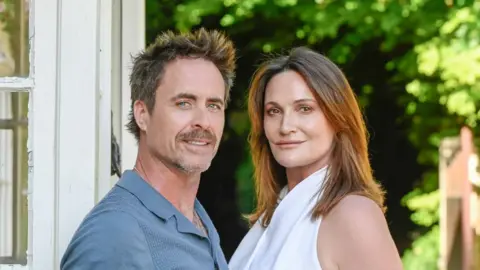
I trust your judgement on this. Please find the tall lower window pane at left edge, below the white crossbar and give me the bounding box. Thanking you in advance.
[0,92,28,264]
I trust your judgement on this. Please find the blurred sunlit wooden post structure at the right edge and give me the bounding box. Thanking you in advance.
[439,127,480,270]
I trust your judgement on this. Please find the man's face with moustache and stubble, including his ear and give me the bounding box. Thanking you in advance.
[135,58,225,174]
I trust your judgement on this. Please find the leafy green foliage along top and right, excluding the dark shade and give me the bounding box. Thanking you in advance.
[147,0,480,269]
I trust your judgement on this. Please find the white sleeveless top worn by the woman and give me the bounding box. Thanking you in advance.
[229,167,327,270]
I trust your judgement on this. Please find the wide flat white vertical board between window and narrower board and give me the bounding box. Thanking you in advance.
[55,0,100,264]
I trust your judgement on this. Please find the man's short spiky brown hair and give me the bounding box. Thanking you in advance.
[127,28,236,141]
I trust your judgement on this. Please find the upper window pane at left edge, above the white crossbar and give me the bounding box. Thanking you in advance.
[0,0,29,77]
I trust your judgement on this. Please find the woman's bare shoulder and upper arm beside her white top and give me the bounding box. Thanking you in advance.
[318,195,401,269]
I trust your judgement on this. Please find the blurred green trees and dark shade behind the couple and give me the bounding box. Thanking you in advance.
[142,0,480,269]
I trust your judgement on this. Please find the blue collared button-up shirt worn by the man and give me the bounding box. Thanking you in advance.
[60,171,228,270]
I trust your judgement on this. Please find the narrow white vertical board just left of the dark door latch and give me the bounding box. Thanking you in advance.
[95,0,113,202]
